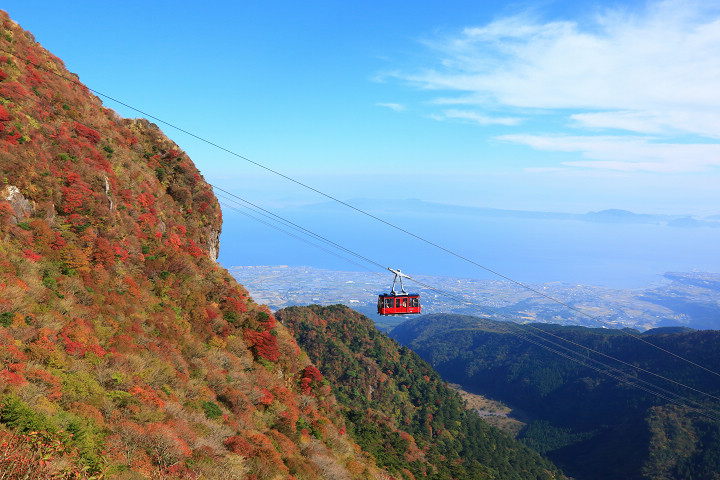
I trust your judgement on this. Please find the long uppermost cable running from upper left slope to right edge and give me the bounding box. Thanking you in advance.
[5,48,720,377]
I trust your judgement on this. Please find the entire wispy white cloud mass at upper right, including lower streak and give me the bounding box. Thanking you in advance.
[399,0,720,172]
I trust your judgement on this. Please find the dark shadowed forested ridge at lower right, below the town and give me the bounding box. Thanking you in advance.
[391,315,720,480]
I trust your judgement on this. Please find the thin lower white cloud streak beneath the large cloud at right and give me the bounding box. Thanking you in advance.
[498,134,720,173]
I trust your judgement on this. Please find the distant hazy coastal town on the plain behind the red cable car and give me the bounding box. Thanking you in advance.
[228,265,720,331]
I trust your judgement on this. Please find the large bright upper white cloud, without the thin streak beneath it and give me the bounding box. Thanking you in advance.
[406,1,720,124]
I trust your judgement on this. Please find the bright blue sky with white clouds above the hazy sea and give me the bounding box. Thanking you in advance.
[2,0,720,216]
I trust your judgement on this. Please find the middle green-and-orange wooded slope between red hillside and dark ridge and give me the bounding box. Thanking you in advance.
[276,305,561,479]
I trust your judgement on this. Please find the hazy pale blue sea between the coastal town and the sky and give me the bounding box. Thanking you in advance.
[219,204,720,289]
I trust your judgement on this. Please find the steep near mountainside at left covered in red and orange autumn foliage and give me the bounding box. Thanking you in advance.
[0,13,389,479]
